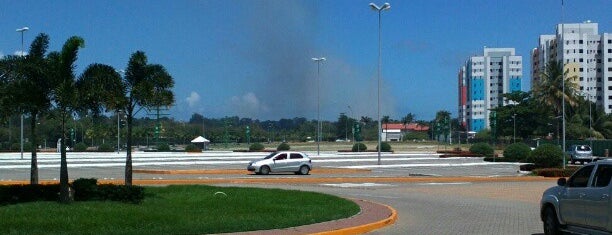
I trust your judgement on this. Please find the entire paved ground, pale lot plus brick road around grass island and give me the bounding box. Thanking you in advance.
[0,152,555,234]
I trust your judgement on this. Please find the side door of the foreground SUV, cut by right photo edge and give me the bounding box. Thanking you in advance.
[584,164,612,230]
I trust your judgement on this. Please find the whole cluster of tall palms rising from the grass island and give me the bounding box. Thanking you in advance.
[0,33,174,202]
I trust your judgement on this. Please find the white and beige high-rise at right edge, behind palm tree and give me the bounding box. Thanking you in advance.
[531,21,612,113]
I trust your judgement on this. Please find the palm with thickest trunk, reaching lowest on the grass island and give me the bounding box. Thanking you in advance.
[48,36,85,203]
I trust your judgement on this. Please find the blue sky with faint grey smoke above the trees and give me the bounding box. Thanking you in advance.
[0,0,612,120]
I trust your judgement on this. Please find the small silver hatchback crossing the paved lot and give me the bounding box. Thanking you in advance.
[247,151,312,175]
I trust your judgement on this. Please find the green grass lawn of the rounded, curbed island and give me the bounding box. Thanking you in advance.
[0,185,359,235]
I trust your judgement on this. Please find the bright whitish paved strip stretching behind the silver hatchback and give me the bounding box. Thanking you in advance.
[0,152,521,181]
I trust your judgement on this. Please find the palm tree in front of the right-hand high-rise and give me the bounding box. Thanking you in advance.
[533,61,578,115]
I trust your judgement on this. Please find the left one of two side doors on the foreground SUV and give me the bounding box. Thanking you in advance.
[559,165,595,225]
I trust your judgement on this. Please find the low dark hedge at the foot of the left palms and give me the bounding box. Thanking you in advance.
[0,179,145,205]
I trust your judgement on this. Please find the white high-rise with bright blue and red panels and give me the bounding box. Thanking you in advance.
[458,48,523,132]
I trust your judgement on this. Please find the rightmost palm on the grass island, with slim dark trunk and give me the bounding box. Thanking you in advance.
[118,51,174,186]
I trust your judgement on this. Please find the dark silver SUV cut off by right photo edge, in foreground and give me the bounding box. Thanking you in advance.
[540,159,612,235]
